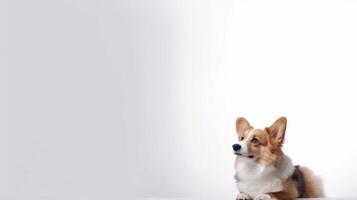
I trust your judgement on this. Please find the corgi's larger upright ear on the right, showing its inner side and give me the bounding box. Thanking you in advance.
[265,117,287,146]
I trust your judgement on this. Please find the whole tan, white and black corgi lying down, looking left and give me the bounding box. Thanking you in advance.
[233,117,324,200]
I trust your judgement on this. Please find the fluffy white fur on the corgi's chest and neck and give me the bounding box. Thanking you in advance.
[235,156,294,198]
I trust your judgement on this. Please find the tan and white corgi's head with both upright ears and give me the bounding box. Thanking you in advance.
[233,117,287,165]
